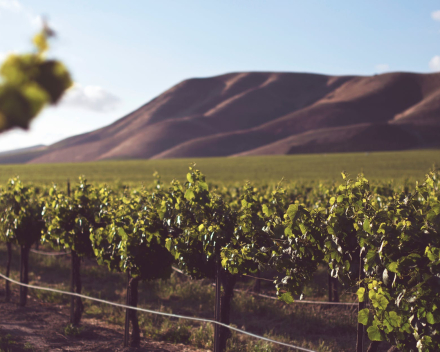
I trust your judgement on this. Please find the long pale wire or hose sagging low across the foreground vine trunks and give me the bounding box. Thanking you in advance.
[0,273,317,352]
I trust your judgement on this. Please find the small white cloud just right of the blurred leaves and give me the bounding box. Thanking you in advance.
[61,84,121,112]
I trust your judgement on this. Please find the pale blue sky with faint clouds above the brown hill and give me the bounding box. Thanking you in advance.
[0,0,440,151]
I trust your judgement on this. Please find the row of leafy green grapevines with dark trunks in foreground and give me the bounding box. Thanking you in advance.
[0,166,440,352]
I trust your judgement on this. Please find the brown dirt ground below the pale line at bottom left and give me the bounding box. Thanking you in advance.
[0,291,206,352]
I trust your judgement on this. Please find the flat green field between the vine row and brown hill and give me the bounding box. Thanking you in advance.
[0,150,440,184]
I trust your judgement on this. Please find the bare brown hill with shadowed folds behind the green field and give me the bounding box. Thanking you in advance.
[0,72,440,163]
